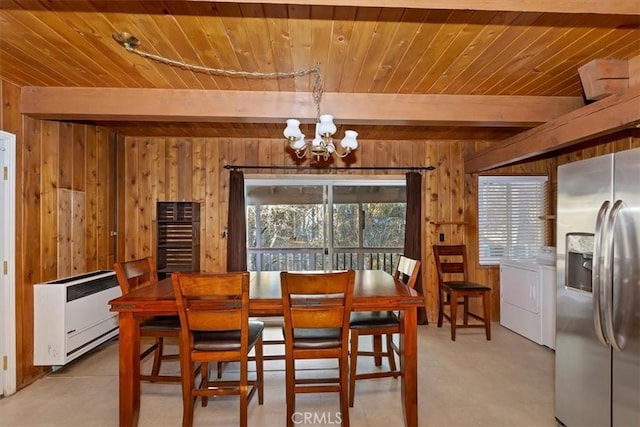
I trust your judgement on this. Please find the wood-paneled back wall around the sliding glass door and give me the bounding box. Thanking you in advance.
[118,137,552,321]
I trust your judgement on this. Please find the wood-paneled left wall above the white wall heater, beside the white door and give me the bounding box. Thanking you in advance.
[0,81,115,388]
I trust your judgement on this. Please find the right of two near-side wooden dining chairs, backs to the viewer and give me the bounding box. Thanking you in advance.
[280,270,355,427]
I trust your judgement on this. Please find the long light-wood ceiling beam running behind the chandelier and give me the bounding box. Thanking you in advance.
[20,87,583,127]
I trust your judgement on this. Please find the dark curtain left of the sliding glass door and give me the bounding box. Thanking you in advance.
[227,171,247,272]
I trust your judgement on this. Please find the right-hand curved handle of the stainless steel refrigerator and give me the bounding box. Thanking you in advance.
[603,200,624,351]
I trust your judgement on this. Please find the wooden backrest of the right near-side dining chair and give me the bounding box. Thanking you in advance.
[280,270,355,342]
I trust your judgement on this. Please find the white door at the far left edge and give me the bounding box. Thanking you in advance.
[0,131,16,396]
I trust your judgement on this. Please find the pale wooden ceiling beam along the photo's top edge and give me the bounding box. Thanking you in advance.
[202,0,640,15]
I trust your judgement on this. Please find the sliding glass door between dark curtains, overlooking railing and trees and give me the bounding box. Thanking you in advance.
[245,177,406,272]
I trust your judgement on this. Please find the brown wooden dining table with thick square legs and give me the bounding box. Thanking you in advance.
[109,270,424,427]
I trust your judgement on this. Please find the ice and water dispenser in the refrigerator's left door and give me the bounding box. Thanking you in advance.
[565,233,594,292]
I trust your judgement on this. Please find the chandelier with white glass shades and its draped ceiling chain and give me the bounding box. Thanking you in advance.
[112,32,358,161]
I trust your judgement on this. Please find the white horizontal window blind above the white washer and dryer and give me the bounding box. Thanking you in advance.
[478,176,547,265]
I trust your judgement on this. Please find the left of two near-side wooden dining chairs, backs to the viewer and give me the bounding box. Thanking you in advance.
[172,272,264,427]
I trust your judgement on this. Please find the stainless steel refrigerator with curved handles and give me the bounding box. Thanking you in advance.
[555,149,640,427]
